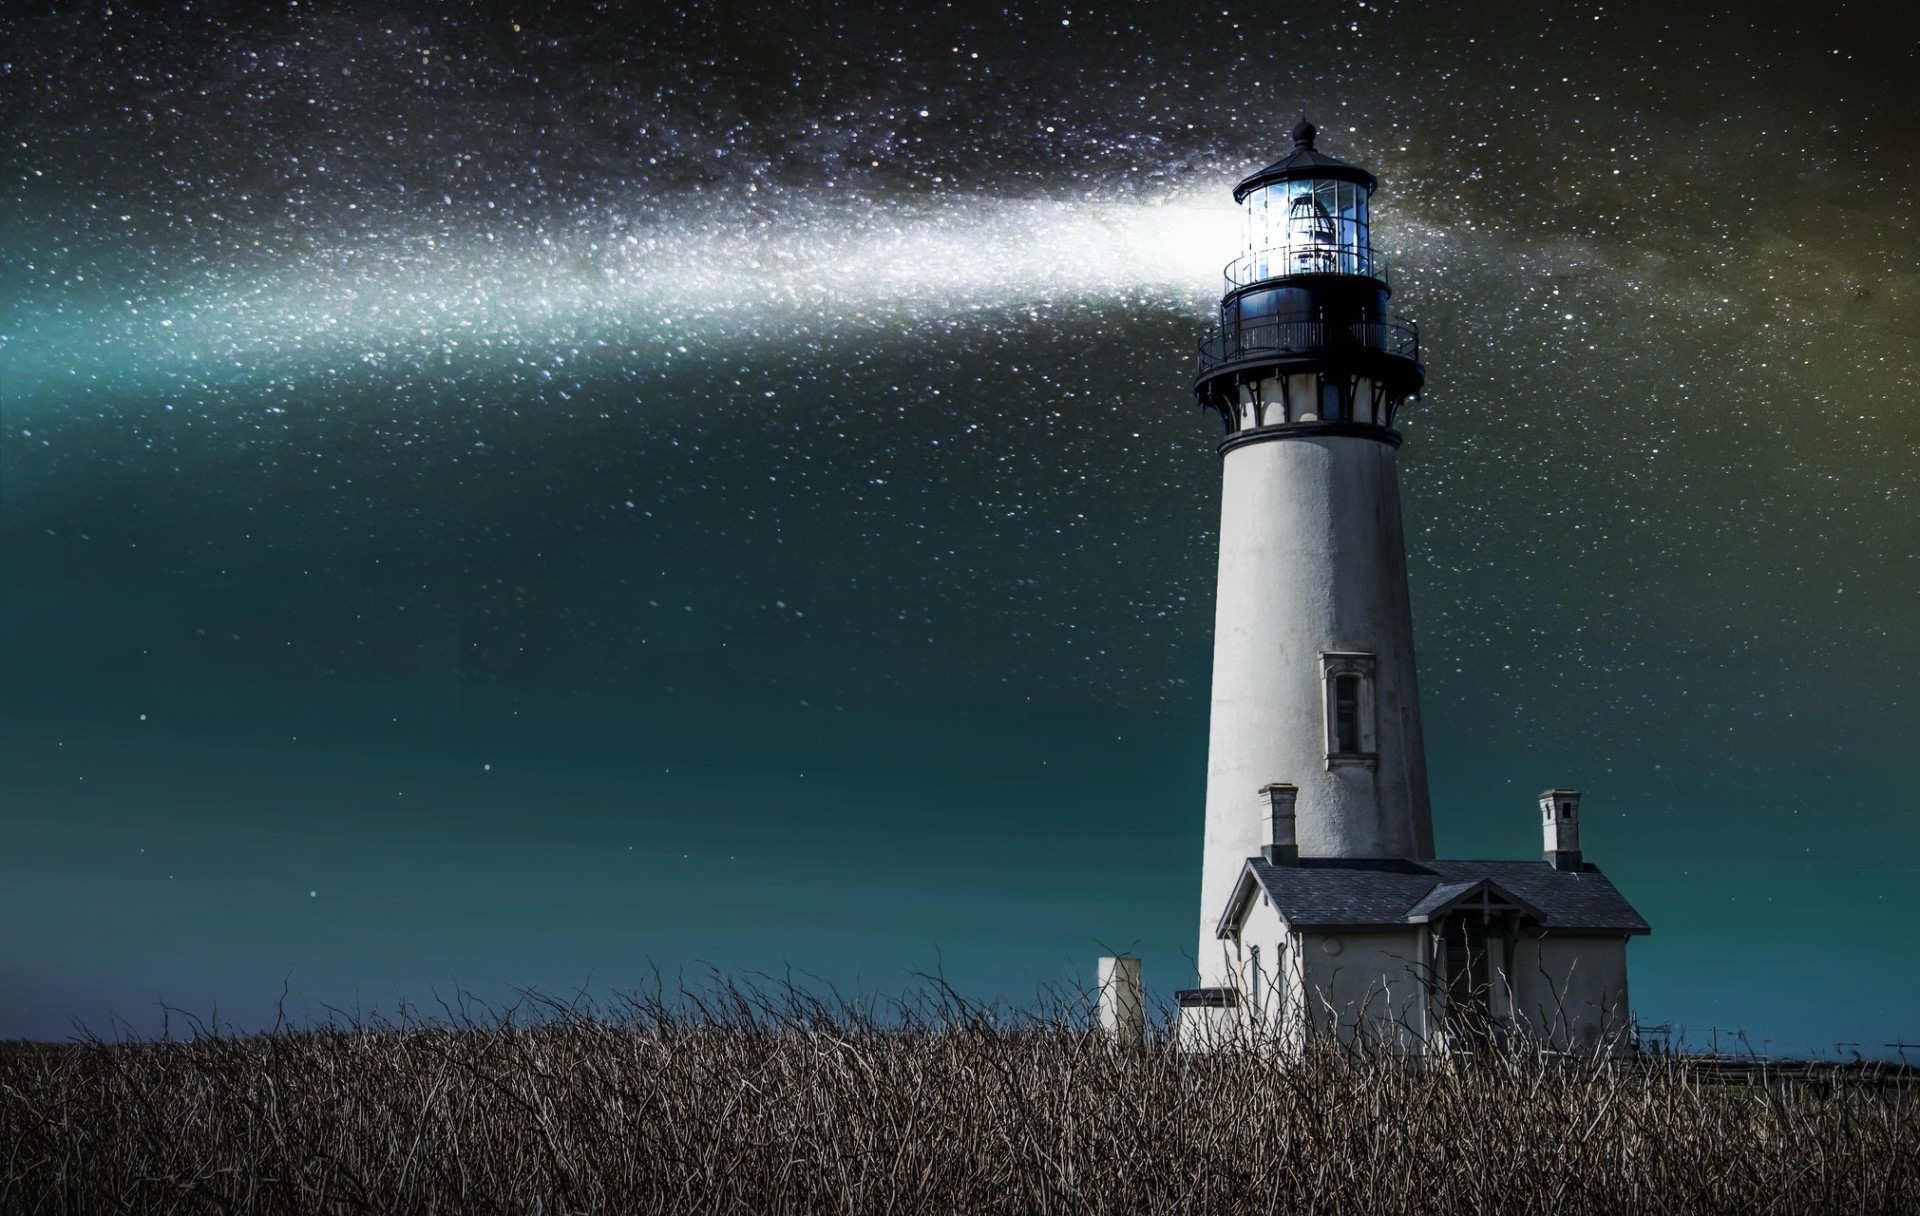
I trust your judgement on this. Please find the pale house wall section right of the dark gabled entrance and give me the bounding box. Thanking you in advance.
[1496,934,1630,1051]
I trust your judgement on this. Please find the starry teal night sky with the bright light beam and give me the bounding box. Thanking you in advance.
[0,0,1920,1053]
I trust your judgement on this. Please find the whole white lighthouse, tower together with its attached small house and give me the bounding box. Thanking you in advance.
[1179,119,1647,1051]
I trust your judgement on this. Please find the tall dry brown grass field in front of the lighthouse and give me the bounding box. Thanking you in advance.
[0,985,1920,1216]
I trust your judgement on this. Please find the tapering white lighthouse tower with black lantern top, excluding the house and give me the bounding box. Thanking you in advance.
[1194,121,1432,968]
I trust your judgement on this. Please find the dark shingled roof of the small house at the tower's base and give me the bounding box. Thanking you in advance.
[1219,857,1649,937]
